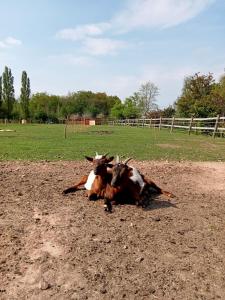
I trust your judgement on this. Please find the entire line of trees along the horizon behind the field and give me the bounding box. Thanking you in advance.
[0,66,225,122]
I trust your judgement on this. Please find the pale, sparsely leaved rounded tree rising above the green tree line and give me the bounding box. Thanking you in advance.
[138,81,159,115]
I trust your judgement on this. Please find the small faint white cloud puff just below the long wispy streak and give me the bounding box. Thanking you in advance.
[83,38,127,55]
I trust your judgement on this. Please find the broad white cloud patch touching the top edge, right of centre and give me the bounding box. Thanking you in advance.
[111,0,214,33]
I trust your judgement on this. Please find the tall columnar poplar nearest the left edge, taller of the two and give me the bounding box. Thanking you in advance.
[2,67,15,119]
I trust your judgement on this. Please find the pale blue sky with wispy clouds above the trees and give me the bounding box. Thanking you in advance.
[0,0,225,108]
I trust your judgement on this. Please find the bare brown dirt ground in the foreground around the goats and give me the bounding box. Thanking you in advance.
[0,161,225,300]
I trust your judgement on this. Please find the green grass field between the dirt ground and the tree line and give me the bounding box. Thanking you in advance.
[0,124,225,161]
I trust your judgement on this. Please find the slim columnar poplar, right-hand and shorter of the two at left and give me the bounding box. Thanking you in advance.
[20,71,31,119]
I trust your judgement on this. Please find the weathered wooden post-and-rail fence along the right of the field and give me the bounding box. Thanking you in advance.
[109,115,225,138]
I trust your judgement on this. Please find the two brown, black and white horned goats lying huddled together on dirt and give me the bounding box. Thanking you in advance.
[63,153,173,212]
